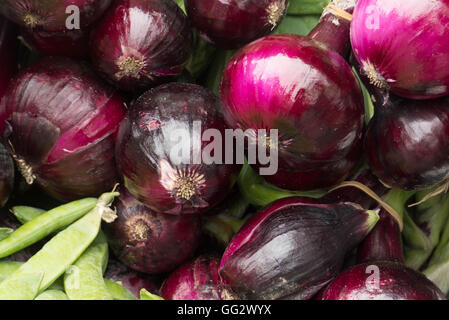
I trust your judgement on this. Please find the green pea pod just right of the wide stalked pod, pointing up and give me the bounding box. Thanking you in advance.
[64,232,113,300]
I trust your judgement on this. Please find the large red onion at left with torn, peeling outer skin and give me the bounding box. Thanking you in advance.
[0,57,126,200]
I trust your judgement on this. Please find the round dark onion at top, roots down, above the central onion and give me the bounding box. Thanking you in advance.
[90,0,192,92]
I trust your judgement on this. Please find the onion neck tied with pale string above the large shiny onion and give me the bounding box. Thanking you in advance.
[309,0,356,58]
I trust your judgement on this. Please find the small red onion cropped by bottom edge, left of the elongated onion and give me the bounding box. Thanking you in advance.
[160,255,224,300]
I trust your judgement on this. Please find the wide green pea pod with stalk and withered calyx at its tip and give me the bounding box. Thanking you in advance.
[0,192,119,298]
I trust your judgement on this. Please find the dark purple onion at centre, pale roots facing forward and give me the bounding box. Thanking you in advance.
[116,82,241,215]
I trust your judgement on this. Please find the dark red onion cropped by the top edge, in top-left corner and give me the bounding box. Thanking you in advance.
[0,0,111,31]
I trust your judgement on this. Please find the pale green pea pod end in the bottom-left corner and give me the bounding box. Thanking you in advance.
[0,272,44,300]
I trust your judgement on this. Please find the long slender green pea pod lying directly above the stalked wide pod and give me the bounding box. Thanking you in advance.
[0,198,97,258]
